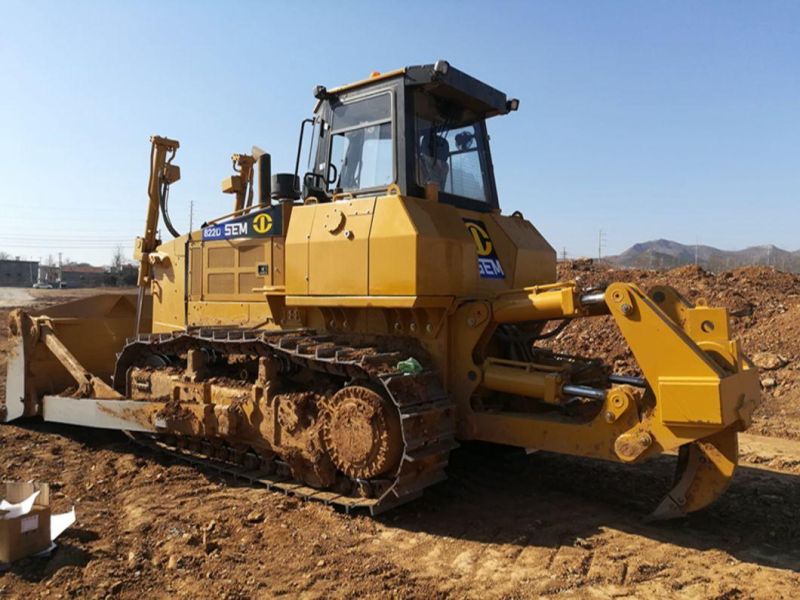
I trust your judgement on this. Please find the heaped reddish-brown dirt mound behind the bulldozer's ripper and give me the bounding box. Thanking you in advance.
[543,259,800,439]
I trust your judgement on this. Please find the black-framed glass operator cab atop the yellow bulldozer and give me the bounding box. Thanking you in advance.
[297,61,519,212]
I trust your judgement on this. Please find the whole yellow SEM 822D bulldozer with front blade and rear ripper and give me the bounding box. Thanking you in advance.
[0,60,760,519]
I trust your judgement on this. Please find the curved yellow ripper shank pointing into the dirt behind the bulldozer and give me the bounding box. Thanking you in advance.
[648,429,739,521]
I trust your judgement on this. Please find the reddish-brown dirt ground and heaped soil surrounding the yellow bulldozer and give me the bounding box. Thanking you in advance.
[0,274,800,599]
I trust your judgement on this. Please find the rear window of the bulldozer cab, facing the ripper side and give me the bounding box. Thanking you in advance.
[415,92,487,202]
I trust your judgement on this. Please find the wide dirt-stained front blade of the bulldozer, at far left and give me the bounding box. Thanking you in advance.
[0,294,151,423]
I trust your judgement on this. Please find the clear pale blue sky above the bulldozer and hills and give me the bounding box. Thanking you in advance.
[0,0,800,264]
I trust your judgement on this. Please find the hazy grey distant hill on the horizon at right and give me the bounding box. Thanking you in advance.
[604,240,800,273]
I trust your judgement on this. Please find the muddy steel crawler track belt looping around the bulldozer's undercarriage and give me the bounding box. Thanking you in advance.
[114,329,457,514]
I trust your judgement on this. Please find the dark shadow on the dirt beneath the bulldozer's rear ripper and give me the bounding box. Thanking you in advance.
[378,444,800,571]
